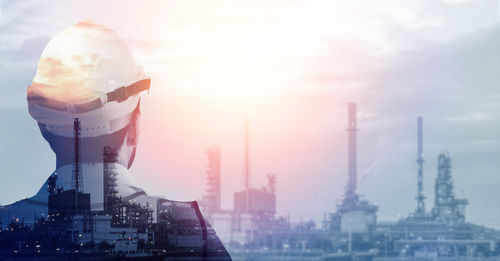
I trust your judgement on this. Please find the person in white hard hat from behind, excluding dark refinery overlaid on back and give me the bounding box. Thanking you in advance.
[0,21,230,260]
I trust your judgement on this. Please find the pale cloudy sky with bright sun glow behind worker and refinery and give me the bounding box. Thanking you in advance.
[0,0,500,228]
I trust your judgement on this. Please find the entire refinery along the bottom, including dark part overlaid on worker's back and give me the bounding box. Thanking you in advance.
[0,103,500,261]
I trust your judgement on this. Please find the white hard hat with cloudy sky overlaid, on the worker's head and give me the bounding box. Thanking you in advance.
[28,20,150,137]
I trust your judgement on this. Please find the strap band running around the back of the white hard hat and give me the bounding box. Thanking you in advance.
[28,79,151,114]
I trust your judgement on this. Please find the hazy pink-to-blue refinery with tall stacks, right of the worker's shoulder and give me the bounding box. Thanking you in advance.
[201,103,500,261]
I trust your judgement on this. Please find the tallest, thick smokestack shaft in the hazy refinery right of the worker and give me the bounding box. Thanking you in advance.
[347,103,358,196]
